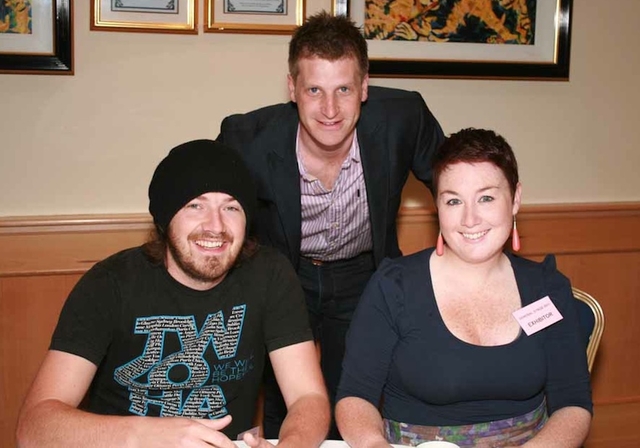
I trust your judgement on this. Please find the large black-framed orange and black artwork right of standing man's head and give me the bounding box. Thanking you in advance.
[333,0,572,81]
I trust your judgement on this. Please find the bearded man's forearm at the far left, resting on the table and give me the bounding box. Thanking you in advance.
[16,400,138,448]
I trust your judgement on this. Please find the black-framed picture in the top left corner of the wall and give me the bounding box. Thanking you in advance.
[0,0,73,75]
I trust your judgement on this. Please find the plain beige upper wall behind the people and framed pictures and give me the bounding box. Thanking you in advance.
[0,0,640,216]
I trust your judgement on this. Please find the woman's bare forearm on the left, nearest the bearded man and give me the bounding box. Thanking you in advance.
[336,397,390,448]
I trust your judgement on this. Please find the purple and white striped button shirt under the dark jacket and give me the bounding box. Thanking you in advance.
[296,132,373,261]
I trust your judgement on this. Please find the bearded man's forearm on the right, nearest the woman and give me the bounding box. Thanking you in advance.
[278,394,331,448]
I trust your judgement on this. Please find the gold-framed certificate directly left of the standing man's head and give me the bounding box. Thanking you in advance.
[204,0,305,34]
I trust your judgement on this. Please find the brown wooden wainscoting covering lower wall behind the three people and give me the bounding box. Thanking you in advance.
[0,203,640,448]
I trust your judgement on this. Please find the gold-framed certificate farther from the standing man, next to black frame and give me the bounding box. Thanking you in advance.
[89,0,198,34]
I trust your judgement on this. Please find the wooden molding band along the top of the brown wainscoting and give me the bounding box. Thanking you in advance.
[0,202,640,277]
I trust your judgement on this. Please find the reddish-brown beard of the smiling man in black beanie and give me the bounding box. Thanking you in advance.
[167,231,238,283]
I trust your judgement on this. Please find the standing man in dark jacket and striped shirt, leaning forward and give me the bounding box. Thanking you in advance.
[218,12,444,438]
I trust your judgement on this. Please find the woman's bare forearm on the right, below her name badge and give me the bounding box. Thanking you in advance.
[523,406,591,448]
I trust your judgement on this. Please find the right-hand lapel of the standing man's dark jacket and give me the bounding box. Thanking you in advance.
[357,111,389,263]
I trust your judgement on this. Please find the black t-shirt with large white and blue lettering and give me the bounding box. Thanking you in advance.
[50,248,312,438]
